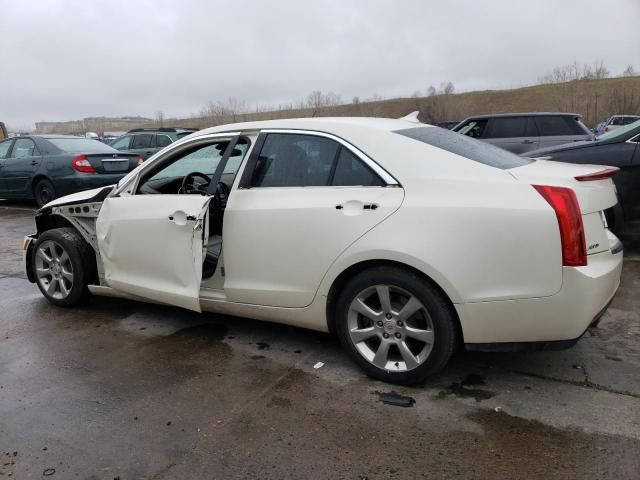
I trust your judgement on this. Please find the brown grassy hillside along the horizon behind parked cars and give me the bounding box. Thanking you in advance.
[36,76,640,133]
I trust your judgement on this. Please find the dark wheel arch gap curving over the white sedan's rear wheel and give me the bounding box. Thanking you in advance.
[326,259,464,345]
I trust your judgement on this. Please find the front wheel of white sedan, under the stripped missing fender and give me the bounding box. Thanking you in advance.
[31,228,95,307]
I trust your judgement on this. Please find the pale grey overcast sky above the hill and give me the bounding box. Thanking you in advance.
[0,0,640,128]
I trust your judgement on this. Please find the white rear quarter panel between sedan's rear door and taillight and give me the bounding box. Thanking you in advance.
[322,179,562,303]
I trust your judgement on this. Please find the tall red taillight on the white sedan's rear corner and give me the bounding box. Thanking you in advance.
[532,185,587,267]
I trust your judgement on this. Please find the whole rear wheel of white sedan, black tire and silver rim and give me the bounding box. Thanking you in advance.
[336,267,456,385]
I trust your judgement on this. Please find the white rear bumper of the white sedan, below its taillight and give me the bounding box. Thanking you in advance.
[455,244,622,344]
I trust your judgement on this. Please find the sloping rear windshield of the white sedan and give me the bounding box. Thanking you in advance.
[395,127,533,170]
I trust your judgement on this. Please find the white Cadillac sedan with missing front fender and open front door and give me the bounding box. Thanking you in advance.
[24,118,622,384]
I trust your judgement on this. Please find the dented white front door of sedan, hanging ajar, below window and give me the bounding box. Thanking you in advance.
[96,195,211,312]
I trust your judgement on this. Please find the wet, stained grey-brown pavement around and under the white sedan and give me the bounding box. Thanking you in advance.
[0,203,640,480]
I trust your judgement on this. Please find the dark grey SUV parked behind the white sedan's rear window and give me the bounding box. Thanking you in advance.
[453,112,593,153]
